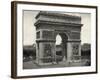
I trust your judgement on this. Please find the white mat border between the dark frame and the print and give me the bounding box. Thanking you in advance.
[17,4,96,76]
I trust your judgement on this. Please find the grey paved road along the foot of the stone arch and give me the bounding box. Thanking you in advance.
[23,60,88,69]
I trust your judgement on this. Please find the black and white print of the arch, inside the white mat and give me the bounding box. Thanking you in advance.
[23,11,91,69]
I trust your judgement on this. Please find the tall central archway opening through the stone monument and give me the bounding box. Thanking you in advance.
[55,33,68,61]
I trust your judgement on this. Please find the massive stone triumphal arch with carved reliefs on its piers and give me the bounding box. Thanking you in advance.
[34,11,82,65]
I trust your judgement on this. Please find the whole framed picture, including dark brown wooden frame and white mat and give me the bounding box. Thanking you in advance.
[11,1,97,78]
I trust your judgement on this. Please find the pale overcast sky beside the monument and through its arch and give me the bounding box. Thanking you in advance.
[23,11,91,45]
